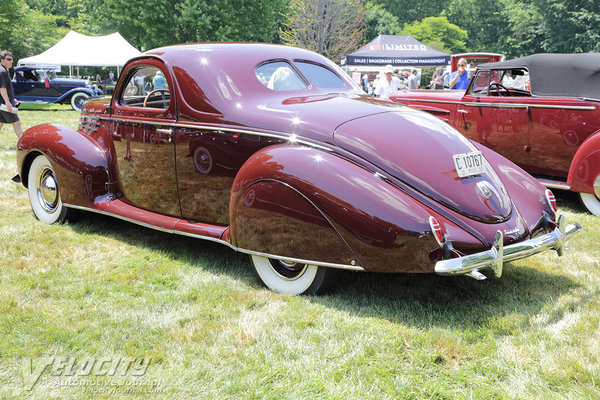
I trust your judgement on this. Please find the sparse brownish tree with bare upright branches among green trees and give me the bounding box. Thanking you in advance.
[280,0,366,62]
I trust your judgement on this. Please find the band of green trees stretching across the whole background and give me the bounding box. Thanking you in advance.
[0,0,600,61]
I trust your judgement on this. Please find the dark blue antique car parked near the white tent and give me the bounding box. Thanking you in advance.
[12,65,102,111]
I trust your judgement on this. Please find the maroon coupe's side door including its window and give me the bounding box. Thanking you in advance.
[111,59,181,216]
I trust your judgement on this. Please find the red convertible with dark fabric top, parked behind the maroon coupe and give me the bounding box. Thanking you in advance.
[390,53,600,216]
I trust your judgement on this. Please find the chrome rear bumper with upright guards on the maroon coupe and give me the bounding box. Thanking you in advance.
[435,215,581,280]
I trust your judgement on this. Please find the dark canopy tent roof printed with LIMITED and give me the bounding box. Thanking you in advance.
[341,35,450,67]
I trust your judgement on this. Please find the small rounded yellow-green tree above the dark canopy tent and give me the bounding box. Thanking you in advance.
[402,17,468,53]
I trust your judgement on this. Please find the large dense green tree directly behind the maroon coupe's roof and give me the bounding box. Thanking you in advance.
[85,0,286,50]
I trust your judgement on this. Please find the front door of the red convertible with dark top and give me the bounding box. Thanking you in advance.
[454,71,531,166]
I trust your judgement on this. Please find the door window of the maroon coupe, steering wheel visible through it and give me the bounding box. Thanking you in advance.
[119,66,171,109]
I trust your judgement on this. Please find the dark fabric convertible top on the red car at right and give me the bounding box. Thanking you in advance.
[477,53,600,100]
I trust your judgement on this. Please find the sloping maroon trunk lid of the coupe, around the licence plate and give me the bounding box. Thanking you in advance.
[334,109,512,223]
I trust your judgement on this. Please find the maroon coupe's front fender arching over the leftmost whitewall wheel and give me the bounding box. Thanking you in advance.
[17,124,109,207]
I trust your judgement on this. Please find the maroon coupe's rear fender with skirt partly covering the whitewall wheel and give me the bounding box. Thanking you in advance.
[230,145,458,272]
